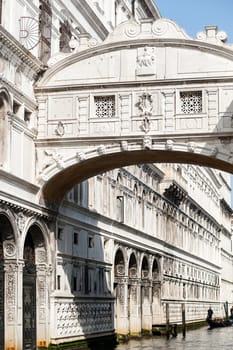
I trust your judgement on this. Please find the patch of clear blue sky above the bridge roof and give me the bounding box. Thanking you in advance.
[155,0,233,44]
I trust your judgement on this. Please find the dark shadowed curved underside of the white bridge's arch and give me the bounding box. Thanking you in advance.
[40,150,233,205]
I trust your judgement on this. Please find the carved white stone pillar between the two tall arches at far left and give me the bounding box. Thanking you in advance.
[4,259,24,350]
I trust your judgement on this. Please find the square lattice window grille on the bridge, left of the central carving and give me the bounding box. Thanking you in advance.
[94,96,116,118]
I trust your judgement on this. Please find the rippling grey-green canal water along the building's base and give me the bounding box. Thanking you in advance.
[114,326,233,350]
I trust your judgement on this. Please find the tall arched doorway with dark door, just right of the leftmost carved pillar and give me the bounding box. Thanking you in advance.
[22,221,50,348]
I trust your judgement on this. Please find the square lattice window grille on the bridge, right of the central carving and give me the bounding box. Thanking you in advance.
[180,91,202,114]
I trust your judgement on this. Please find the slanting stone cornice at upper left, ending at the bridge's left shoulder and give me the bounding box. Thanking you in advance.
[0,25,45,74]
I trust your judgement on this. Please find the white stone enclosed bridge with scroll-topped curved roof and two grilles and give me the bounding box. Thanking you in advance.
[35,19,233,204]
